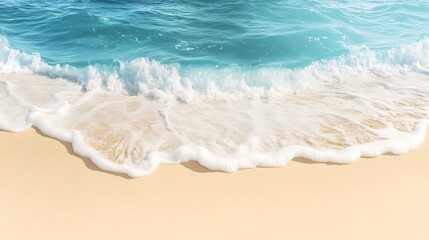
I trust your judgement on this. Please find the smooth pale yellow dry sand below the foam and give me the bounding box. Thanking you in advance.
[0,126,429,240]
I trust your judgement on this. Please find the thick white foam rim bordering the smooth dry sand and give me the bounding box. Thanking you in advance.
[8,107,429,177]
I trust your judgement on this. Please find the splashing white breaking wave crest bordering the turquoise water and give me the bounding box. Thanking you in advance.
[0,35,429,103]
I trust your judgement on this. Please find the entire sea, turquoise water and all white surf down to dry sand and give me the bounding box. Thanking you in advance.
[0,0,429,177]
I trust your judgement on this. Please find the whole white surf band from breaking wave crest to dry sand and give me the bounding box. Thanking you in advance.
[0,37,429,177]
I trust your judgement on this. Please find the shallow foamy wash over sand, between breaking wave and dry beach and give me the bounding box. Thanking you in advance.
[0,73,429,177]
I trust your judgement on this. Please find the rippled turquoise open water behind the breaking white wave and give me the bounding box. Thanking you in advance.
[0,0,429,68]
